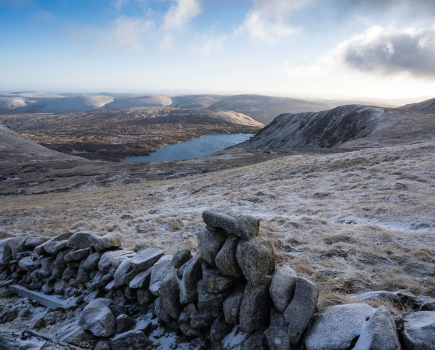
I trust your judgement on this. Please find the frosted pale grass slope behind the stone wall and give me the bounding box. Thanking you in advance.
[0,138,435,313]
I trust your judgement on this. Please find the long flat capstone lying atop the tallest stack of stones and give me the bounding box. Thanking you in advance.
[202,210,260,239]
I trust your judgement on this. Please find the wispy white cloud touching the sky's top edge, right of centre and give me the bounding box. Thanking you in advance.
[236,0,312,45]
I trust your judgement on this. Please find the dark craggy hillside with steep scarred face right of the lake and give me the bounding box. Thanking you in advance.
[233,105,435,149]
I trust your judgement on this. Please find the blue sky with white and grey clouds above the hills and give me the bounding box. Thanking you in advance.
[0,0,435,98]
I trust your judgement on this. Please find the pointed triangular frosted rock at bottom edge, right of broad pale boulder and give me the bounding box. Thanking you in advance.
[353,305,401,350]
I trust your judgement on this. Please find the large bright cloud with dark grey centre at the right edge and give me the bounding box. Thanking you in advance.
[283,25,435,79]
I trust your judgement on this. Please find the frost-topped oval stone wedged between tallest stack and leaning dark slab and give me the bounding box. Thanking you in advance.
[269,265,297,313]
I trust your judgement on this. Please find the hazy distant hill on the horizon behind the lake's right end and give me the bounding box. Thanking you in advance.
[207,95,333,124]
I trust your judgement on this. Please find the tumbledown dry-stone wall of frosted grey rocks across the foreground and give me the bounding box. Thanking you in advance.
[0,210,435,350]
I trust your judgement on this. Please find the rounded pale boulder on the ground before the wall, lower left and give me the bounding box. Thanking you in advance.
[79,299,116,337]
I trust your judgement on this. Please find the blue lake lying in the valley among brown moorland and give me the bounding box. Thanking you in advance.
[123,134,254,162]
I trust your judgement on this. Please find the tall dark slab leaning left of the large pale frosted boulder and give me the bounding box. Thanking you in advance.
[284,277,319,344]
